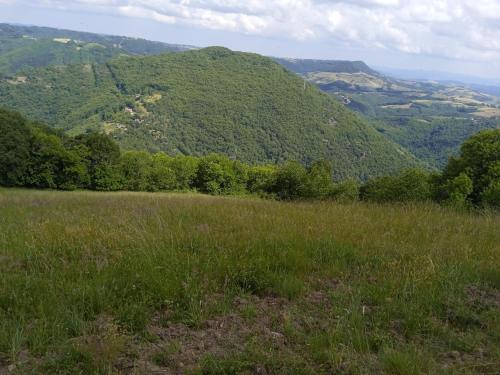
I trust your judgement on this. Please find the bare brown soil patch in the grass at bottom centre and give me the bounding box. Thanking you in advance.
[130,296,289,374]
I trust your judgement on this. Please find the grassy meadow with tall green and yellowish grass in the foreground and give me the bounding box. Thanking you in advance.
[0,190,500,374]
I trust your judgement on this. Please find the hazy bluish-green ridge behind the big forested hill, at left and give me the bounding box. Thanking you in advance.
[0,24,193,75]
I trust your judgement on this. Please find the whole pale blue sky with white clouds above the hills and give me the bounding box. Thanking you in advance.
[0,0,500,79]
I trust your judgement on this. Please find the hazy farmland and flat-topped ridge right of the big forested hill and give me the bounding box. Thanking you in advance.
[279,55,500,168]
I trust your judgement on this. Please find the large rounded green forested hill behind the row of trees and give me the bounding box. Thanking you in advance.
[0,47,417,179]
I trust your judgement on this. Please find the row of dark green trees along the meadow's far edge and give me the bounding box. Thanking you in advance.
[0,109,500,208]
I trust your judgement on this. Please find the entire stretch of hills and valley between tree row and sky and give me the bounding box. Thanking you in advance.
[0,24,500,175]
